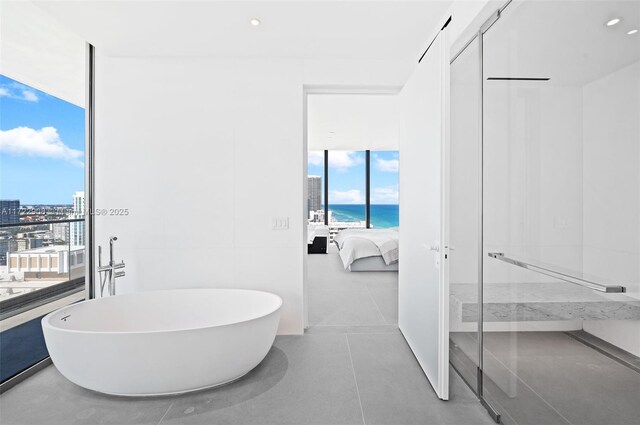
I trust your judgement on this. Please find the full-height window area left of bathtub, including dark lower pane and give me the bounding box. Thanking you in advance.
[0,2,87,388]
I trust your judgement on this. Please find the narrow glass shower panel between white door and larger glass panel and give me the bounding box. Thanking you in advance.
[449,38,481,392]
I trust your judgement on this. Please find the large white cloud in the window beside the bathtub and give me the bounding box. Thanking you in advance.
[0,127,84,167]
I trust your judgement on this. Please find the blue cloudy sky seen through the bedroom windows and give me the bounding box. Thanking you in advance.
[308,151,399,205]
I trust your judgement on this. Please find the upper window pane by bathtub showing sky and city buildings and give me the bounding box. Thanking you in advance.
[0,75,85,294]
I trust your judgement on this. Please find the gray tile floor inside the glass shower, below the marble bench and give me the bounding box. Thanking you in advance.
[452,332,640,425]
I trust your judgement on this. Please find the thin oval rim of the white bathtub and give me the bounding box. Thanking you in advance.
[40,288,283,336]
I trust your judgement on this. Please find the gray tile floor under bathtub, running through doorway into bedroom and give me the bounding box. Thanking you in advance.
[0,250,493,425]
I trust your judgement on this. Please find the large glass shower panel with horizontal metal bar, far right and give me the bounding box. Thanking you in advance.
[482,0,640,424]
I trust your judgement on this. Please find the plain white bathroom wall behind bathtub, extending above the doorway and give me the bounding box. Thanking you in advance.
[96,54,413,334]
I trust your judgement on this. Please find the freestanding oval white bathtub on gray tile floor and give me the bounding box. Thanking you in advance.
[42,289,282,396]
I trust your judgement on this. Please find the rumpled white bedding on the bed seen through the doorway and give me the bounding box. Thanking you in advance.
[334,229,398,270]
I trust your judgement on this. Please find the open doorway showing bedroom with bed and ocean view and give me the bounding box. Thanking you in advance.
[303,88,400,334]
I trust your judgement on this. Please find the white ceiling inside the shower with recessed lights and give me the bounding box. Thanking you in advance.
[483,0,640,86]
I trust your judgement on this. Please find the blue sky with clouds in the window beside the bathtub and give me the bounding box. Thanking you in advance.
[0,75,84,205]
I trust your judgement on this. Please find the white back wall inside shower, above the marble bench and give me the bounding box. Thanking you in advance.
[484,81,582,283]
